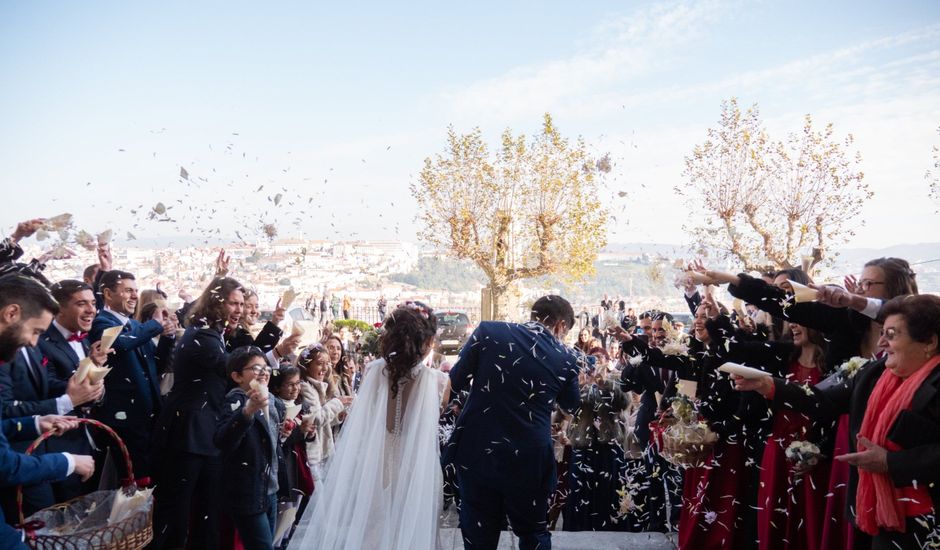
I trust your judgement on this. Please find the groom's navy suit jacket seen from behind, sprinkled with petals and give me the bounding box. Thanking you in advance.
[442,321,586,490]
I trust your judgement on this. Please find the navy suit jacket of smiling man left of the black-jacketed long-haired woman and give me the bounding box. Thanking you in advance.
[89,310,173,430]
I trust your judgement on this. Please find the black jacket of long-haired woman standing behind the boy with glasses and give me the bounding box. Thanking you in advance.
[154,327,230,456]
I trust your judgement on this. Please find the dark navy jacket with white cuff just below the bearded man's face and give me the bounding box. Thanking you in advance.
[0,347,66,434]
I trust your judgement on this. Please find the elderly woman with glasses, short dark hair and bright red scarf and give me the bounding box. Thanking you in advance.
[735,295,940,550]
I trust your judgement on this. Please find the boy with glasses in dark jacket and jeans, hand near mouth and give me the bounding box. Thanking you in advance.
[215,347,280,550]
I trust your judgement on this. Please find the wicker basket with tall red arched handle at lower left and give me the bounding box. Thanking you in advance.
[16,418,153,550]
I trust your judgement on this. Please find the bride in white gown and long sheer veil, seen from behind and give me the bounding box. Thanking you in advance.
[299,302,450,550]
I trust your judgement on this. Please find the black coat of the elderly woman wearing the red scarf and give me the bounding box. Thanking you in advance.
[773,359,940,524]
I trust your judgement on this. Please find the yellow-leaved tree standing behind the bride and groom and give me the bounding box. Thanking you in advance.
[411,114,610,319]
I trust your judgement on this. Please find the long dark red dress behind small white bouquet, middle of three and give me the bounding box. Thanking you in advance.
[757,361,830,550]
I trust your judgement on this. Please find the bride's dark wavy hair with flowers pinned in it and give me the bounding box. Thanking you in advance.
[379,302,437,398]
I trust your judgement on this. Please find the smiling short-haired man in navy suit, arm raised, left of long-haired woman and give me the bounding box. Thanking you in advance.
[90,270,175,485]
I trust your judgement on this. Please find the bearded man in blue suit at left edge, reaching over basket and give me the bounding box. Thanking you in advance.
[0,275,95,549]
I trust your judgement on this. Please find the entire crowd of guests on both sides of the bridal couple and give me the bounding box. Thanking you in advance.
[0,220,940,549]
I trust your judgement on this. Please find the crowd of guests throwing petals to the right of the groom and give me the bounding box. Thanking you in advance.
[552,258,940,549]
